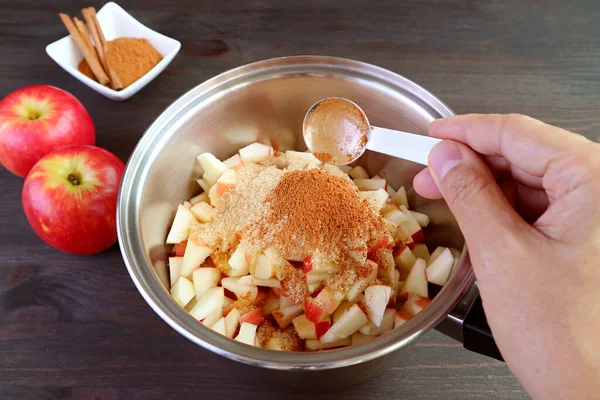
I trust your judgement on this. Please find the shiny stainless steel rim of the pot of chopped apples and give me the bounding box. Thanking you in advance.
[117,56,475,370]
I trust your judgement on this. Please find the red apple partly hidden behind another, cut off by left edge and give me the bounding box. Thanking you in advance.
[0,85,96,178]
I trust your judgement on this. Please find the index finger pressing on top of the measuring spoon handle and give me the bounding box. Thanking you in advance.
[429,114,591,177]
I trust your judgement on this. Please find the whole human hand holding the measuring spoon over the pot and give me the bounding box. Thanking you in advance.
[414,115,600,399]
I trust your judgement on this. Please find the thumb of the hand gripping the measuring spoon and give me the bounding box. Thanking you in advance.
[429,141,525,247]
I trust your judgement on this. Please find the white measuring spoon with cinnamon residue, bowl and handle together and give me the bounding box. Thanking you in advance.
[302,97,440,165]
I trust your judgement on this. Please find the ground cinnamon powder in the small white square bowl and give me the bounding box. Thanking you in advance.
[77,38,162,87]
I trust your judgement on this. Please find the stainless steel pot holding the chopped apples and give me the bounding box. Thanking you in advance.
[118,57,500,388]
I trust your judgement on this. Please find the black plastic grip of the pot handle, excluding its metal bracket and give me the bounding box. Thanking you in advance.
[462,295,504,361]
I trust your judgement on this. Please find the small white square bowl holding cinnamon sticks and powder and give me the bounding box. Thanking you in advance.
[46,2,181,101]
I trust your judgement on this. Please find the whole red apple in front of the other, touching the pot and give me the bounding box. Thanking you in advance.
[22,146,125,254]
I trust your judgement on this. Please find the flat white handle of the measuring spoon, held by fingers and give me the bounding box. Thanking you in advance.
[367,126,441,165]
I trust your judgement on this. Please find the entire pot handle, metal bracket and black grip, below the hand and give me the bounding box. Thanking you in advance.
[436,283,504,361]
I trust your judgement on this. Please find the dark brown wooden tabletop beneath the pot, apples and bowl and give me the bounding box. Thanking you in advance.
[0,0,600,400]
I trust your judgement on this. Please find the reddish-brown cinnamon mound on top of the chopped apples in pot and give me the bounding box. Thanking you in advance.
[263,168,385,272]
